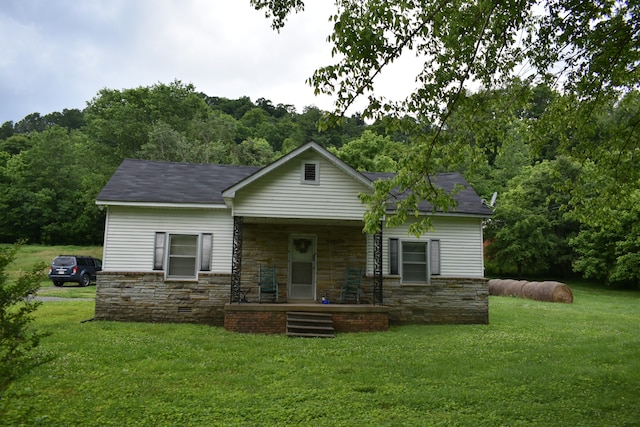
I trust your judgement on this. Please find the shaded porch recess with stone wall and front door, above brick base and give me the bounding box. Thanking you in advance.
[230,217,382,306]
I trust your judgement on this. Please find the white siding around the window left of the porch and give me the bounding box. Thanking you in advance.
[103,206,233,273]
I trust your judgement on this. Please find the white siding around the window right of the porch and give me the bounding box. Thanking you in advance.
[367,216,484,277]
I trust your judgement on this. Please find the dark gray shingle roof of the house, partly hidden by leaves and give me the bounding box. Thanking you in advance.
[97,159,492,216]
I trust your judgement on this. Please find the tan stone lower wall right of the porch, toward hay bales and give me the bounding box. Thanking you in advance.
[383,276,489,325]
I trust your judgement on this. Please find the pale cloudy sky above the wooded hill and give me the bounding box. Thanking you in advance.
[0,0,422,124]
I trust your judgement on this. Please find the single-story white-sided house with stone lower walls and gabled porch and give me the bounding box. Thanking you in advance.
[95,142,491,332]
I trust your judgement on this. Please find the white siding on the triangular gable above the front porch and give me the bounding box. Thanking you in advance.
[233,153,367,220]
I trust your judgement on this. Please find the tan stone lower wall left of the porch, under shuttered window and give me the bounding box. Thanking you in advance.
[95,272,231,326]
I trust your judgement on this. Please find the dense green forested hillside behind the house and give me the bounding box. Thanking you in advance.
[0,81,640,286]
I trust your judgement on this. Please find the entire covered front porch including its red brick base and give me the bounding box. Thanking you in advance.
[224,217,389,334]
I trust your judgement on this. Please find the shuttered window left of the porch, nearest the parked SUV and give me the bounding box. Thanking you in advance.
[153,232,213,279]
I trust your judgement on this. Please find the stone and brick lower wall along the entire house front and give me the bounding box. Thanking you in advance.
[95,272,489,333]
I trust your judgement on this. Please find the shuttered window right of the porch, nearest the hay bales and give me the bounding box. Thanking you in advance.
[389,238,440,283]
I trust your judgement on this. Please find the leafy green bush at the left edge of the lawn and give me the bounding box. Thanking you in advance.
[0,244,50,400]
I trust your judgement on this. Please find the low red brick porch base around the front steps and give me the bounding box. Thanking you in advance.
[224,303,389,334]
